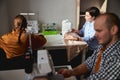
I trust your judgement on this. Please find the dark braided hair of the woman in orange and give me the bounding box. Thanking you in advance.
[14,15,27,43]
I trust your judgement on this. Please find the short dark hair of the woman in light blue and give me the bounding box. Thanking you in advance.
[85,7,100,18]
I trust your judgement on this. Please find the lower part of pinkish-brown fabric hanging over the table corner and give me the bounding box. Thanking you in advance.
[66,40,88,61]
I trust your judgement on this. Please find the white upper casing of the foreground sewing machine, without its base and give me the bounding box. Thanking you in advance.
[37,50,55,75]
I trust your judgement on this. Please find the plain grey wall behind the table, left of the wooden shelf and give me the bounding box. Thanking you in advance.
[7,0,76,30]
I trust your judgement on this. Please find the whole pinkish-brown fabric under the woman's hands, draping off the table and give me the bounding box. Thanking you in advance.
[64,32,88,61]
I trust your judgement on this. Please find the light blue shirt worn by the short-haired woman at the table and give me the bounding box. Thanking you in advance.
[80,21,98,50]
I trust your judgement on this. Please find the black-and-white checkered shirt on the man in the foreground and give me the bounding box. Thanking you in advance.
[84,40,120,80]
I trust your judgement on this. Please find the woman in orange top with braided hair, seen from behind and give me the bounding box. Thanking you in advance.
[0,15,46,59]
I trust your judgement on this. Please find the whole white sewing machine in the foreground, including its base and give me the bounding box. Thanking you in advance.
[32,50,64,80]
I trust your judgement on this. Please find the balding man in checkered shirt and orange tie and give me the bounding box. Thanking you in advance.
[58,13,120,80]
